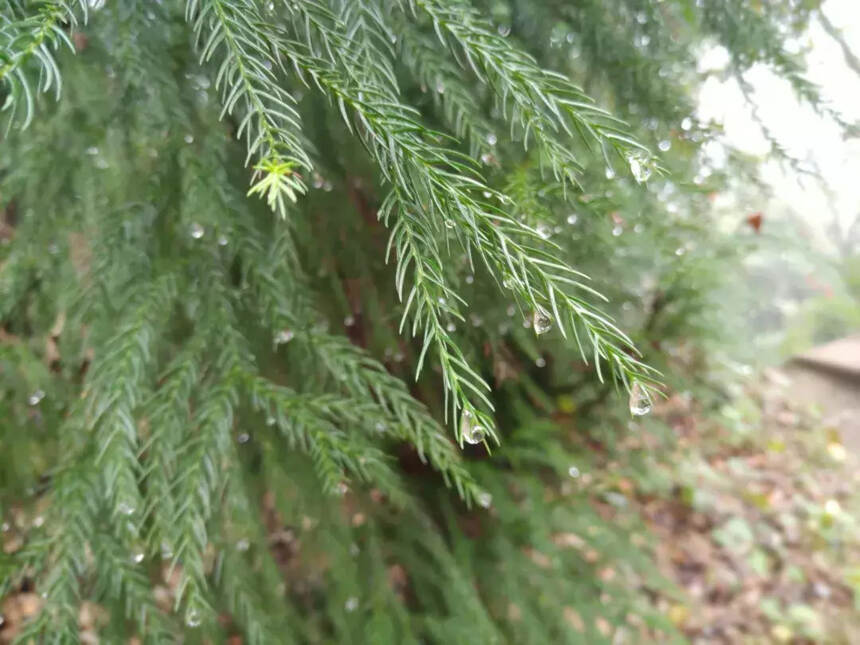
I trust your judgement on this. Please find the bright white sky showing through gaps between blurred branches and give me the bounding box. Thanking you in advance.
[698,0,860,250]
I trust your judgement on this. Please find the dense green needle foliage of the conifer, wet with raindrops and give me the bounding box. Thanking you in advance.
[0,0,838,643]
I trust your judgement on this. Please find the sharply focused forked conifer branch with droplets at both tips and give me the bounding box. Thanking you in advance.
[270,9,654,430]
